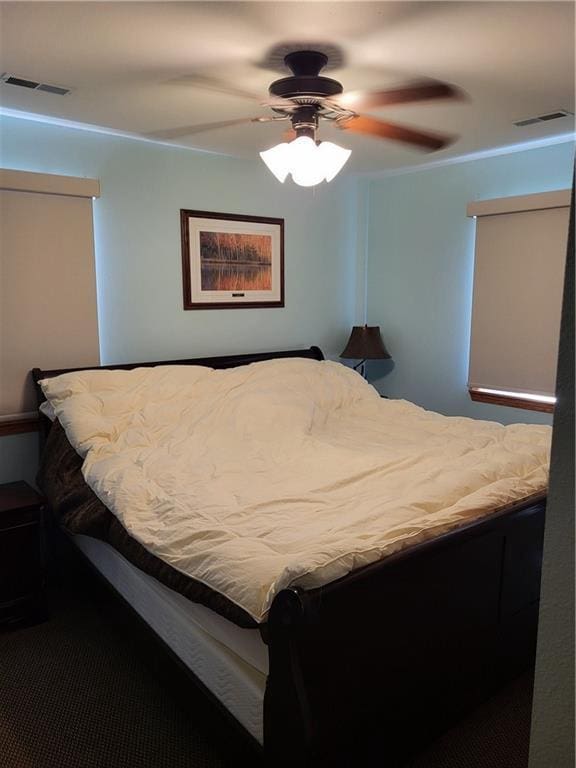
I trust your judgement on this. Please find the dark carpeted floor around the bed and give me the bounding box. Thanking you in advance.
[0,568,532,768]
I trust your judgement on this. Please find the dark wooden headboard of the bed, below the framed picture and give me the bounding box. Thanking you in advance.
[32,347,324,416]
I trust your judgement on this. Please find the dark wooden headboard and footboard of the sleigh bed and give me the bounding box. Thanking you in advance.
[33,347,545,768]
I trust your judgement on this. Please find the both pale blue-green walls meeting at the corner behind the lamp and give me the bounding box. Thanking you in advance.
[0,116,573,482]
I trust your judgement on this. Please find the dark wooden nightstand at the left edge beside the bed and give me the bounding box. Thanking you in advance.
[0,482,47,629]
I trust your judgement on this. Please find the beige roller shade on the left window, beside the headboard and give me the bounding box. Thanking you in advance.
[0,170,99,434]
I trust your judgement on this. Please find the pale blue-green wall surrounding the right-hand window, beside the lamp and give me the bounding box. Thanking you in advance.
[367,143,574,423]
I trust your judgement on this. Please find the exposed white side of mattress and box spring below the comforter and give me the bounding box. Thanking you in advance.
[73,535,268,744]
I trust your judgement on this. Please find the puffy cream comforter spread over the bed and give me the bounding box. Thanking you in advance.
[41,359,550,621]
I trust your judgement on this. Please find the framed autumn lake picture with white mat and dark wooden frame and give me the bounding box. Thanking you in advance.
[180,210,284,309]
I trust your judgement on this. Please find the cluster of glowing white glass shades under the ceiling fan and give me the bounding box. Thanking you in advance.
[260,136,352,187]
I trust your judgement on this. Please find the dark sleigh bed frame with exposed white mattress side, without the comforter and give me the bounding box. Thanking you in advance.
[33,347,545,766]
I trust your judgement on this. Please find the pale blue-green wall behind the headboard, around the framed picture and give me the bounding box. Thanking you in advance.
[0,117,356,482]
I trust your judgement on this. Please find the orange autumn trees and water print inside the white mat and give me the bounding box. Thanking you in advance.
[199,230,272,292]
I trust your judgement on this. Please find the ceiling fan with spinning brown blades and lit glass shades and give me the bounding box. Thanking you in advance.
[148,50,463,186]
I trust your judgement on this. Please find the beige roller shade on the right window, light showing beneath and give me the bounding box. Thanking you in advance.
[468,190,570,402]
